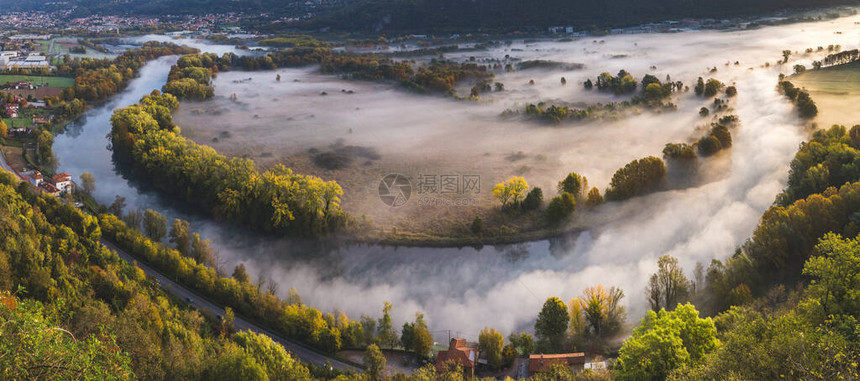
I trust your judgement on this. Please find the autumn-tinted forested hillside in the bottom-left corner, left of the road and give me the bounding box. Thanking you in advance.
[0,172,310,380]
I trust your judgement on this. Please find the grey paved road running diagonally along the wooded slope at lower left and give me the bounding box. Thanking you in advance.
[102,240,361,372]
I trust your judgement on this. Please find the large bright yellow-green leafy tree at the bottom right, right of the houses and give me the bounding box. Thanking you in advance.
[616,303,720,380]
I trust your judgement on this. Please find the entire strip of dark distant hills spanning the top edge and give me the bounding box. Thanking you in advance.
[8,0,860,32]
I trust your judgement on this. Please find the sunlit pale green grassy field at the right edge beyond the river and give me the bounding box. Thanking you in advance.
[790,62,860,127]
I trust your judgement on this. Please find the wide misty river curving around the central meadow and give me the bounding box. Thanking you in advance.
[54,16,860,341]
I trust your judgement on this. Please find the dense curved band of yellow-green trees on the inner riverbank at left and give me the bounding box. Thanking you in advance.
[110,92,346,236]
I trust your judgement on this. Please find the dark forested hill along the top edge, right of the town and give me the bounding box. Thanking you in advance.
[306,0,860,32]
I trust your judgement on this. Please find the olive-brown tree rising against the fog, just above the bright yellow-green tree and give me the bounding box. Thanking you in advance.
[645,255,692,311]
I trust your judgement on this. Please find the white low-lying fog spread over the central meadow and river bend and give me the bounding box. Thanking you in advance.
[61,16,860,341]
